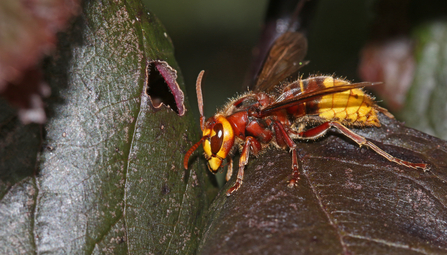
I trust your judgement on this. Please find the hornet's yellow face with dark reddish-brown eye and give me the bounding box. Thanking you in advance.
[203,115,234,173]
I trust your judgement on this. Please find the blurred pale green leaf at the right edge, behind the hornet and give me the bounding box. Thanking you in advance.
[401,21,447,139]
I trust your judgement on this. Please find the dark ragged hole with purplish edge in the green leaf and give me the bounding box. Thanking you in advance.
[146,60,185,116]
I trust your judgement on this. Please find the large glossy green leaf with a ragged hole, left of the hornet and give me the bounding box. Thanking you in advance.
[0,0,207,254]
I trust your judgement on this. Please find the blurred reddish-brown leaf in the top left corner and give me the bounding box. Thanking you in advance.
[0,0,80,123]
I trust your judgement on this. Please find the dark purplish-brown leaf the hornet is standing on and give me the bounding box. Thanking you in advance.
[200,116,447,254]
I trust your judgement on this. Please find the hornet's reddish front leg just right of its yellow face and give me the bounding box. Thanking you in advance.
[227,136,262,196]
